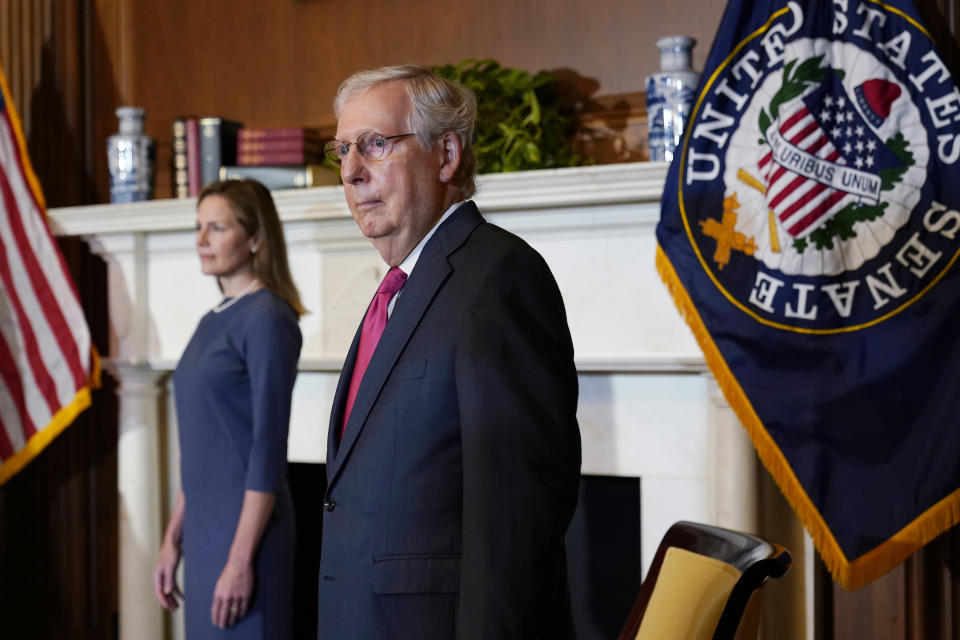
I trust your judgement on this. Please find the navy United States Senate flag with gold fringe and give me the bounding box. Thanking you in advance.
[657,0,960,589]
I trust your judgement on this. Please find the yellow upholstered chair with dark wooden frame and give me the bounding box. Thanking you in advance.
[619,522,791,640]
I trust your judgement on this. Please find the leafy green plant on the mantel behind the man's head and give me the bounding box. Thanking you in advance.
[433,58,582,173]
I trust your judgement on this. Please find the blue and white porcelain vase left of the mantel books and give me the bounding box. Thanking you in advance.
[107,107,156,202]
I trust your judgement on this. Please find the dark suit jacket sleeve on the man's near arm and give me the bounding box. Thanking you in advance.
[456,244,580,639]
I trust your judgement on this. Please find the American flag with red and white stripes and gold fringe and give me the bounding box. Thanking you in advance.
[0,65,100,484]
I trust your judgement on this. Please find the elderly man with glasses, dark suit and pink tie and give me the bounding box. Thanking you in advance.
[318,66,580,640]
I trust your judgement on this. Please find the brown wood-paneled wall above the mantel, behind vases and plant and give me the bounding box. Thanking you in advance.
[99,0,723,197]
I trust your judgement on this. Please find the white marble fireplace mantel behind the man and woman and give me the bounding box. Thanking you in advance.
[49,163,756,639]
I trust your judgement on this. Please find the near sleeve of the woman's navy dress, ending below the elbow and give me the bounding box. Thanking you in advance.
[244,298,302,493]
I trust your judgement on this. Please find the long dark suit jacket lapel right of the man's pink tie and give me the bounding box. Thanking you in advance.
[327,202,483,485]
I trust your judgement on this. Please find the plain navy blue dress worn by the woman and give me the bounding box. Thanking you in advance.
[173,289,302,640]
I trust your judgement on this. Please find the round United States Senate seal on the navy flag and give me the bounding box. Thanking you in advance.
[678,0,960,333]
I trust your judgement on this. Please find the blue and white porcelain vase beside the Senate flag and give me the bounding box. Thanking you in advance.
[647,36,700,162]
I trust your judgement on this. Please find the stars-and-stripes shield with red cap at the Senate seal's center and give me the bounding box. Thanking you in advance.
[759,72,901,239]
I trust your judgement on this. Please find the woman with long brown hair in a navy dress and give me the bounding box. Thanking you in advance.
[154,180,305,640]
